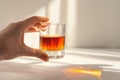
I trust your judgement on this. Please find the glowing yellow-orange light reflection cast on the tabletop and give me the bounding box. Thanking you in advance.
[64,67,102,80]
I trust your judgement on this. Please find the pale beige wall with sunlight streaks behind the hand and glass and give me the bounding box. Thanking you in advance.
[0,0,120,48]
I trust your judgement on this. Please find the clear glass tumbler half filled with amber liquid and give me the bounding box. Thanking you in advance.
[40,23,65,59]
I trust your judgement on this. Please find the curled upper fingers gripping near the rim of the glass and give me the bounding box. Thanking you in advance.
[22,16,50,32]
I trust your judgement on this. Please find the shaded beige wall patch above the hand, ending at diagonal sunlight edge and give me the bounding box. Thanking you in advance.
[0,0,51,29]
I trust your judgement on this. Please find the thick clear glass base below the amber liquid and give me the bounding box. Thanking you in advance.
[45,50,65,59]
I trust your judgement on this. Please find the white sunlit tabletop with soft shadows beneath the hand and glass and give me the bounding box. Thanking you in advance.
[0,49,120,80]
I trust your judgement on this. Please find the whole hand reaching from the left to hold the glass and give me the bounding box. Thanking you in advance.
[0,16,49,61]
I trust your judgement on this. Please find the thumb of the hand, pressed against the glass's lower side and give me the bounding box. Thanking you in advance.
[24,46,49,62]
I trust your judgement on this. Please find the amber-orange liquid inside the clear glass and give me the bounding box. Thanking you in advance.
[40,36,65,51]
